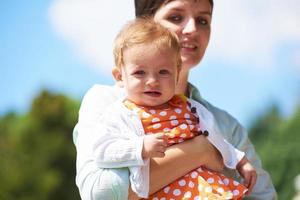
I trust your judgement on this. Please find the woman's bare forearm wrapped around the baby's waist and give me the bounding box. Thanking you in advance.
[149,135,224,194]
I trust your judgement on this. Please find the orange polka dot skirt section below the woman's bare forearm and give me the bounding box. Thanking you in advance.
[149,167,247,200]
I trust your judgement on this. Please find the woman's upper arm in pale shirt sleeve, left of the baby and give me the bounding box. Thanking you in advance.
[73,85,129,199]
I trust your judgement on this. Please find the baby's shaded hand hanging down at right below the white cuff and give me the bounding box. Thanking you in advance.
[237,156,257,195]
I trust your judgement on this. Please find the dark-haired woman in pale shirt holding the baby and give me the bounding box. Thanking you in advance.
[74,0,276,199]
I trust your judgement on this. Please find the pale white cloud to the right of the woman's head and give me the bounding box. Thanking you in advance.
[209,0,300,67]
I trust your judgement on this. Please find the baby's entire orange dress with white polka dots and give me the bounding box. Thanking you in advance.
[124,95,247,200]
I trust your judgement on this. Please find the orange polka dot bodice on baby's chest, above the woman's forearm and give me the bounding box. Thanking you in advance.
[124,95,199,145]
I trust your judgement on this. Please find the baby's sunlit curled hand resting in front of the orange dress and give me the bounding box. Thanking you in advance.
[142,133,167,158]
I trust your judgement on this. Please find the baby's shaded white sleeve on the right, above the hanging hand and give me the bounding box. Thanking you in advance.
[192,101,245,169]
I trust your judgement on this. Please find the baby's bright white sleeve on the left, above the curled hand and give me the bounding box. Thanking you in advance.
[92,112,145,168]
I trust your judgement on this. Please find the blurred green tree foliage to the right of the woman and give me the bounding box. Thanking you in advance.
[250,106,300,199]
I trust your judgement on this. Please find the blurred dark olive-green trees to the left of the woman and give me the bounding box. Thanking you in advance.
[0,91,80,200]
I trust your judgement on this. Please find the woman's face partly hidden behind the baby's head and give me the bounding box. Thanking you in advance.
[154,0,212,71]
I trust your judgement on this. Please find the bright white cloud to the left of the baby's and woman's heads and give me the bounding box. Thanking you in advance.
[49,0,134,72]
